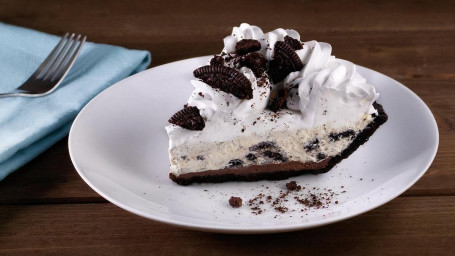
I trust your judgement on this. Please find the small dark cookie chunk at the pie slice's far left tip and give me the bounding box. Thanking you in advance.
[169,106,205,131]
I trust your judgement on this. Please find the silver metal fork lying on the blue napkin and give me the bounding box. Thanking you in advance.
[0,33,87,98]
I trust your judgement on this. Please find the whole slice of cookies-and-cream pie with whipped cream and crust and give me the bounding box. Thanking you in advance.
[166,24,387,185]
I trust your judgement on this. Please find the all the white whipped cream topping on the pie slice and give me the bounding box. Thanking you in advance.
[166,23,379,149]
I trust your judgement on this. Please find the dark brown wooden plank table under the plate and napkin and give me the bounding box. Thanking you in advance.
[0,0,455,255]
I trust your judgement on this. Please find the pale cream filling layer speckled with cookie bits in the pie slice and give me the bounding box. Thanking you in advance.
[169,116,371,176]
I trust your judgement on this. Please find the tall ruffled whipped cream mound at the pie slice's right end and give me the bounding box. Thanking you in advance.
[285,56,379,127]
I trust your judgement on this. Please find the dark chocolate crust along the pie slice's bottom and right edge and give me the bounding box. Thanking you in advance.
[169,102,388,185]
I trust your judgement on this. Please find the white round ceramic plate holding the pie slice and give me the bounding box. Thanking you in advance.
[69,56,439,233]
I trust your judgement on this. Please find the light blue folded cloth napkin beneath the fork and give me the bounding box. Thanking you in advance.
[0,22,151,180]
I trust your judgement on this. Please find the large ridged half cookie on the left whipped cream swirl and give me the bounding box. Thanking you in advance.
[193,66,253,100]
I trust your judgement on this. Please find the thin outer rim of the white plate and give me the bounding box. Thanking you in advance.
[68,55,439,234]
